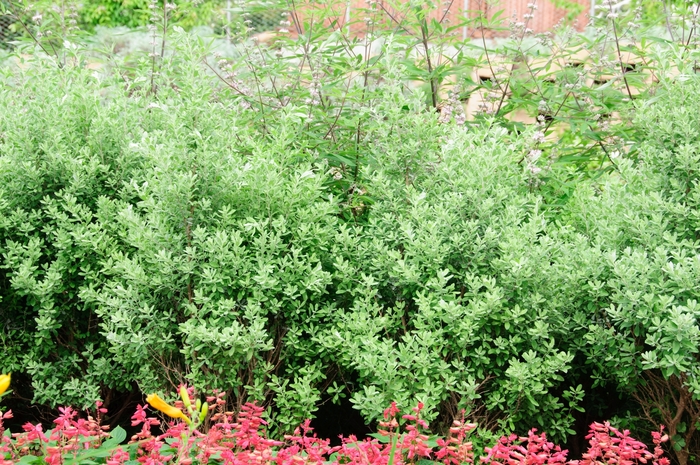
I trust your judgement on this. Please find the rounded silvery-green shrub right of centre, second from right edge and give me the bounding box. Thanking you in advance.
[319,114,585,435]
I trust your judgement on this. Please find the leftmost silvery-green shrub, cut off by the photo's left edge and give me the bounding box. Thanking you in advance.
[0,51,148,406]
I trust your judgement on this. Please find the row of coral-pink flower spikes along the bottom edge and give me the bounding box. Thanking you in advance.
[0,392,670,465]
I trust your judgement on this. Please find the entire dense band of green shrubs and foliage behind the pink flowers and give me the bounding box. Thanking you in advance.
[0,0,700,464]
